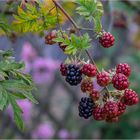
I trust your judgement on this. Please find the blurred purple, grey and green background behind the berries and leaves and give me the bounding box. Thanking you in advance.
[0,0,140,139]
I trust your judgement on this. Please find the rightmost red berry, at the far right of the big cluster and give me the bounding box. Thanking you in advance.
[123,89,139,105]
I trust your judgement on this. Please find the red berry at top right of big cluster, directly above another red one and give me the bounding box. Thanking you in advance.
[116,63,131,77]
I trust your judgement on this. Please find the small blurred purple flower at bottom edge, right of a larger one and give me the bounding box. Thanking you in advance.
[58,129,70,139]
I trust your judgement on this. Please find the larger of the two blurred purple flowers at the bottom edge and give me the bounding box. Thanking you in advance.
[32,122,55,139]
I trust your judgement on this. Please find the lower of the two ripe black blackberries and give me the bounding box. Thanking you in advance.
[78,97,95,119]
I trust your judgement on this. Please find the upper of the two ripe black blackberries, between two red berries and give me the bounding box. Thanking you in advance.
[66,64,82,86]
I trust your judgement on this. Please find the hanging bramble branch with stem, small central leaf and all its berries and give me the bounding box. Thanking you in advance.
[45,0,139,122]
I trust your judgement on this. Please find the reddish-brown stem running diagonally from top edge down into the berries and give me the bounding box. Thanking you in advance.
[52,0,110,95]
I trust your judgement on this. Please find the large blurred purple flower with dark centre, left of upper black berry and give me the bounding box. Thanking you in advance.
[33,58,60,84]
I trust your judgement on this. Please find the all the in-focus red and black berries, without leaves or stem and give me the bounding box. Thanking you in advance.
[45,32,139,122]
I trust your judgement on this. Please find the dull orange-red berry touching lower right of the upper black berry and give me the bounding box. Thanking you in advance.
[81,79,93,92]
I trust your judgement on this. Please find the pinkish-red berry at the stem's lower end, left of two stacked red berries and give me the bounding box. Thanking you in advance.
[97,71,111,87]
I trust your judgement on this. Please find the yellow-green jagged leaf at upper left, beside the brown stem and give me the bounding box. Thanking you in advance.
[12,2,57,33]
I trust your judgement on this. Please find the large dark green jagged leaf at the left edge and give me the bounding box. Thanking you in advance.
[0,48,38,130]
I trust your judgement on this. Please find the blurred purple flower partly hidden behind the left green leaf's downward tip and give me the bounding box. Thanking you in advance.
[7,99,33,123]
